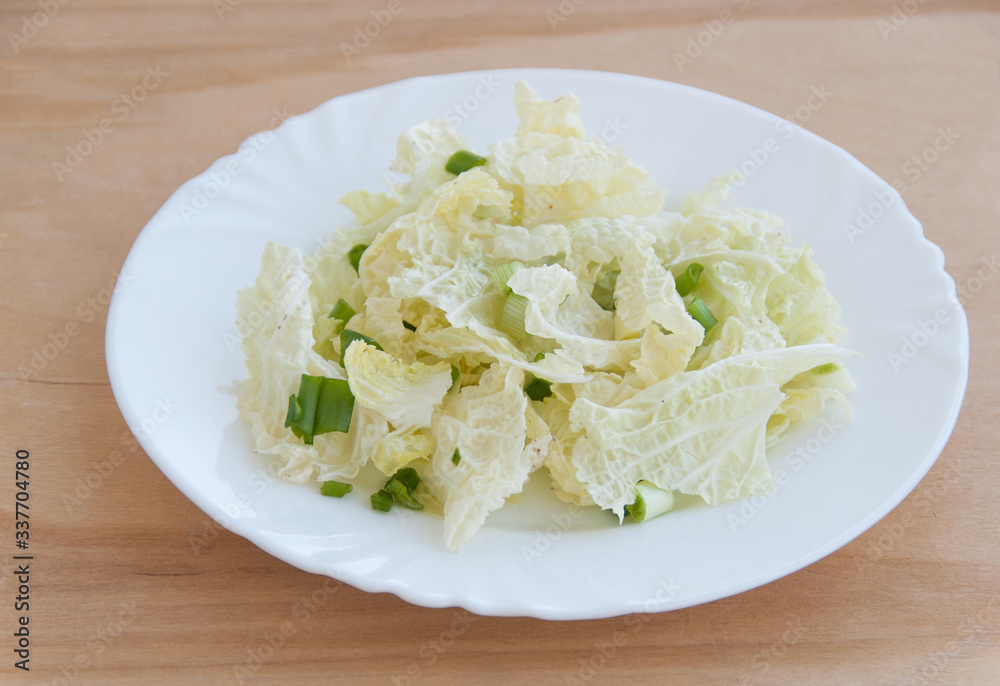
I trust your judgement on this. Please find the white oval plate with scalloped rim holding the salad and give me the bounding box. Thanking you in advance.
[107,70,969,619]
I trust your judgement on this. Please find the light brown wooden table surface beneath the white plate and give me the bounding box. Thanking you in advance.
[0,0,1000,685]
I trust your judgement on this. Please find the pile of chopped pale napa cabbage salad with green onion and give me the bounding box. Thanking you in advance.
[237,82,854,550]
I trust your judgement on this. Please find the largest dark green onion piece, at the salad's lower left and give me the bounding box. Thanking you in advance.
[285,374,354,445]
